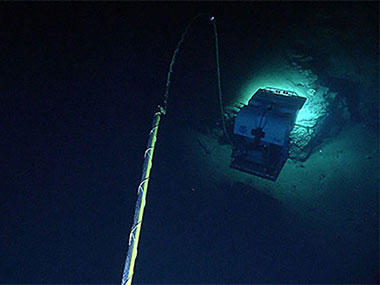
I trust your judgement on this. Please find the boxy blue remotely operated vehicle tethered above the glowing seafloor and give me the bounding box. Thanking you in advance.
[230,87,306,181]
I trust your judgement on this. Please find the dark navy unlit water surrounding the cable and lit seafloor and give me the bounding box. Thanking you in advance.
[0,2,379,284]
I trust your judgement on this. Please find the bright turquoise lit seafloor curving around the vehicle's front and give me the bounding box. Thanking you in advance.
[227,55,349,161]
